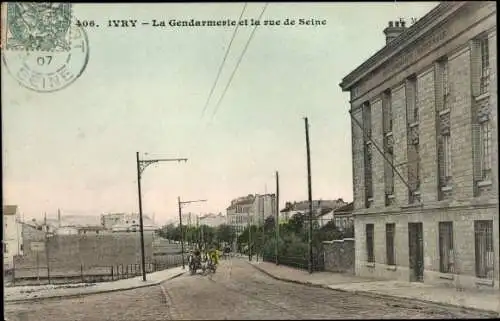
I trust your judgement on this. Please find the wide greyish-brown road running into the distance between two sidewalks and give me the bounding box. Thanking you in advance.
[5,259,493,321]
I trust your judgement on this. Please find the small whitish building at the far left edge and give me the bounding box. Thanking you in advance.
[2,205,23,269]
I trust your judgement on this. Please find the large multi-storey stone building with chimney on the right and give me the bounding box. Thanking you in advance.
[340,1,500,289]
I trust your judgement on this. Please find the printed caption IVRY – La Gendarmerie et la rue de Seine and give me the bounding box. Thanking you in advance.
[108,18,326,28]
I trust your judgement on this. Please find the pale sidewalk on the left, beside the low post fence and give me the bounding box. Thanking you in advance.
[4,267,186,303]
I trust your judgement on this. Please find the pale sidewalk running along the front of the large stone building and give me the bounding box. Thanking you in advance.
[248,262,500,315]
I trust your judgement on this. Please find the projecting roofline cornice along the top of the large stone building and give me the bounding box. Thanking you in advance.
[339,1,467,91]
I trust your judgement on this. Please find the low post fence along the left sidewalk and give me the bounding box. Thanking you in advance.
[4,255,182,286]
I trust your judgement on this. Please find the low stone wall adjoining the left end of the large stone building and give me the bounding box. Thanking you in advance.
[323,238,356,274]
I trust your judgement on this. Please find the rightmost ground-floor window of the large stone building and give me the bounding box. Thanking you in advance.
[474,220,494,279]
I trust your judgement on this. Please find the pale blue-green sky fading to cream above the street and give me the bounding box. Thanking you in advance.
[1,2,437,223]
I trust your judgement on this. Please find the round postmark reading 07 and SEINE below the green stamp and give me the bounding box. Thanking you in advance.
[2,25,89,92]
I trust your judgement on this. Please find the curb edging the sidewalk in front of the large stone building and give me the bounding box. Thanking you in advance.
[247,262,500,316]
